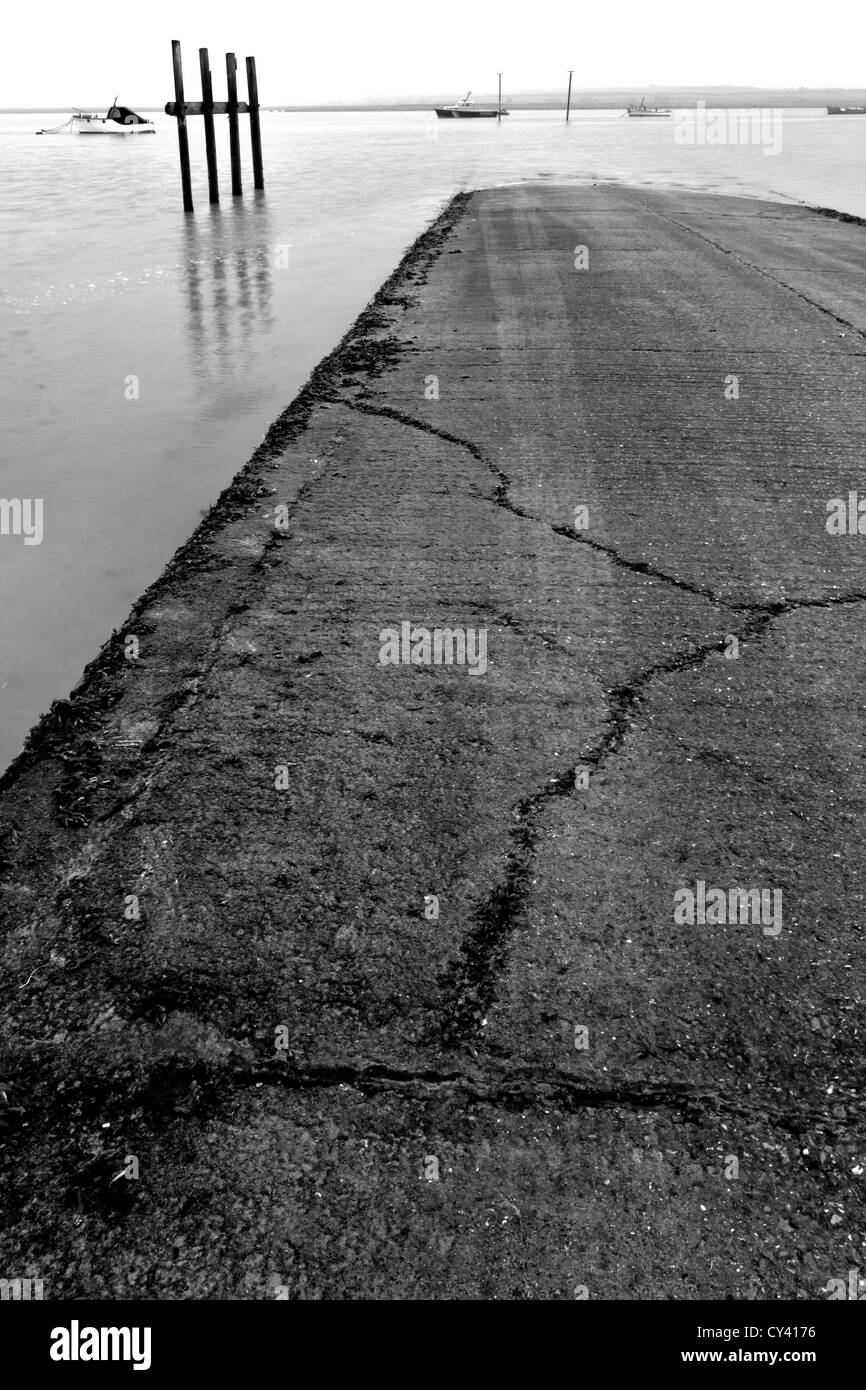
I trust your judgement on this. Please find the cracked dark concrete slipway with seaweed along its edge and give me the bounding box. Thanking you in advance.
[0,186,866,1300]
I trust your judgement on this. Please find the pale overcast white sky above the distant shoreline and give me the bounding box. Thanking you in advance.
[0,0,866,107]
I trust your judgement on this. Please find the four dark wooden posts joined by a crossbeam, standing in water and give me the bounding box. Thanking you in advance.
[165,39,264,213]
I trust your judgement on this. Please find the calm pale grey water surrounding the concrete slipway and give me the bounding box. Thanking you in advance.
[0,111,866,767]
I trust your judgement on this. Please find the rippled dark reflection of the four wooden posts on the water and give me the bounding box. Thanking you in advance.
[179,193,277,392]
